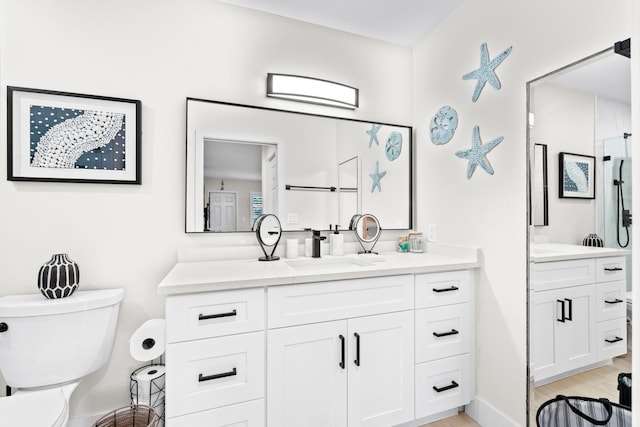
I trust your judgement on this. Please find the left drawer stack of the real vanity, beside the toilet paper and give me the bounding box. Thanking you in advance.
[165,288,265,427]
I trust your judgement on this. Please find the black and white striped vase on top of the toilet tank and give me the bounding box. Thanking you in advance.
[38,254,80,299]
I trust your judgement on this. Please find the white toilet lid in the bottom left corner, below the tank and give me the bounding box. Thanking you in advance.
[0,389,67,427]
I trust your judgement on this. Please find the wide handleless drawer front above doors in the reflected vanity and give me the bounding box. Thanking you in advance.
[531,258,596,291]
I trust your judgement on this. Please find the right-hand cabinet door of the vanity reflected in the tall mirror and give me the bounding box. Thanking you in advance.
[562,285,597,371]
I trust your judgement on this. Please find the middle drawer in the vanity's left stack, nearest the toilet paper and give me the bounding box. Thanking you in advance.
[166,332,265,417]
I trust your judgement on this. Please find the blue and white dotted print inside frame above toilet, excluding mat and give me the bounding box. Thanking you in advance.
[29,105,126,171]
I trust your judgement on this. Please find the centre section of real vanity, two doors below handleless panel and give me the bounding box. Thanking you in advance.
[267,275,414,427]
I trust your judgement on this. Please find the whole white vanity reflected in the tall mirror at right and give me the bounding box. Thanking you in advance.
[529,244,630,386]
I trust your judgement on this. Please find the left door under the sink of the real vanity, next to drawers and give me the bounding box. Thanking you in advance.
[267,320,348,427]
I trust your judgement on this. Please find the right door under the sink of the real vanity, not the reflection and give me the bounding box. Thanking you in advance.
[348,311,414,427]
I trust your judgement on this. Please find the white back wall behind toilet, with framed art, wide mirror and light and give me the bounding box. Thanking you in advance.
[0,0,411,415]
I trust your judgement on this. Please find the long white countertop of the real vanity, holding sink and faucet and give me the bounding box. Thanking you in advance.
[158,245,480,295]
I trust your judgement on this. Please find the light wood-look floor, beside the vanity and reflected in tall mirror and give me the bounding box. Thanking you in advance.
[422,352,631,427]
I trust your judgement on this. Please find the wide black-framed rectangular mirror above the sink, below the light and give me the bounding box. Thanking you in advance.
[185,98,412,233]
